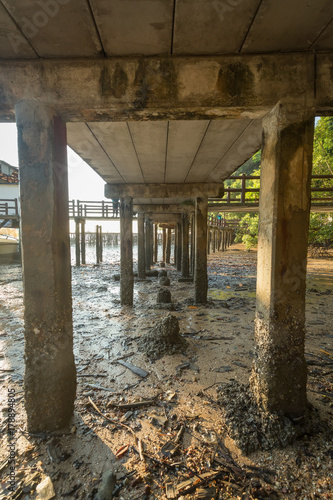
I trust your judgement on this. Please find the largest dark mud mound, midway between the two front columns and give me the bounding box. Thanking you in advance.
[138,314,187,359]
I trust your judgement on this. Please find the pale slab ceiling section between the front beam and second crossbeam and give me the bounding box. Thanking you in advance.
[68,119,261,199]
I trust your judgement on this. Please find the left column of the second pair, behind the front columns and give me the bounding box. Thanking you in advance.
[120,196,134,306]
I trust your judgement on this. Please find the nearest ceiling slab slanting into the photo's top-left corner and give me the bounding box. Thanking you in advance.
[0,0,102,58]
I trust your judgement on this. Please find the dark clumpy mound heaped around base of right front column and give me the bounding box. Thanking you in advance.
[218,381,324,454]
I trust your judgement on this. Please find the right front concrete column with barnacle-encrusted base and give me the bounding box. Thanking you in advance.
[251,103,314,417]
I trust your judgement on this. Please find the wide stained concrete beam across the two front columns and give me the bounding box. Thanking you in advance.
[0,53,326,122]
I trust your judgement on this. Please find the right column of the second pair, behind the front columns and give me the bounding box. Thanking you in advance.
[194,198,208,304]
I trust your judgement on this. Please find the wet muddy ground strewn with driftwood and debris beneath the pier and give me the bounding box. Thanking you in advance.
[0,245,333,500]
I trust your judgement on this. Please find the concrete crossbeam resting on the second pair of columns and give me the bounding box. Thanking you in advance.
[104,182,224,199]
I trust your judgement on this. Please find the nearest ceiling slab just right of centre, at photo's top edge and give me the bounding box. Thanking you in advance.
[173,0,260,54]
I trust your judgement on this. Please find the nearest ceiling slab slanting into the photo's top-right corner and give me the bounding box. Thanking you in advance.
[242,0,333,53]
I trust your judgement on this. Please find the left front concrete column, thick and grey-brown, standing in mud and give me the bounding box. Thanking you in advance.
[15,101,76,433]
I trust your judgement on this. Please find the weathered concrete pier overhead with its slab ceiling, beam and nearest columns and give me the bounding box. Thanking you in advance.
[0,0,333,468]
